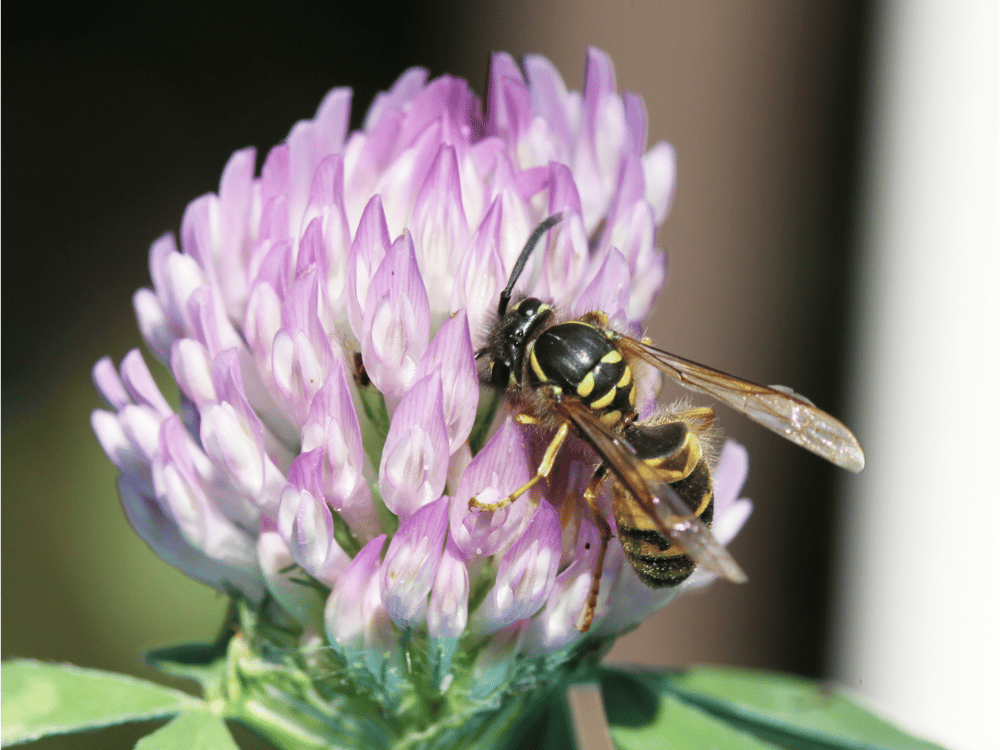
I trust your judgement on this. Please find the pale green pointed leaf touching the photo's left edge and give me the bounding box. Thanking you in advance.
[0,659,204,746]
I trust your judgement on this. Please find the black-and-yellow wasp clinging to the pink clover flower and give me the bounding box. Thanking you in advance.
[469,214,864,632]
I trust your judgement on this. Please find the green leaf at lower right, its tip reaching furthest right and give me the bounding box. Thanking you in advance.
[602,667,942,750]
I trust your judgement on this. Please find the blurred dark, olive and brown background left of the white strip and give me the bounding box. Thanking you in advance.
[2,0,869,747]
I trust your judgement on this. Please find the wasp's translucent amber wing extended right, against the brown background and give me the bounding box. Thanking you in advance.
[614,334,865,471]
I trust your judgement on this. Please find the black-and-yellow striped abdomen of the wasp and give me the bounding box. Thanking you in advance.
[611,418,713,588]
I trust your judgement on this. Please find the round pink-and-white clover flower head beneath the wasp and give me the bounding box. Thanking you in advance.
[92,50,749,748]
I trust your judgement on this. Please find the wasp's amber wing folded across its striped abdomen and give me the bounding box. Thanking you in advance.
[554,399,747,583]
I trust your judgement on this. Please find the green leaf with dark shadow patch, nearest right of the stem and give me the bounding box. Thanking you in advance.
[601,669,775,750]
